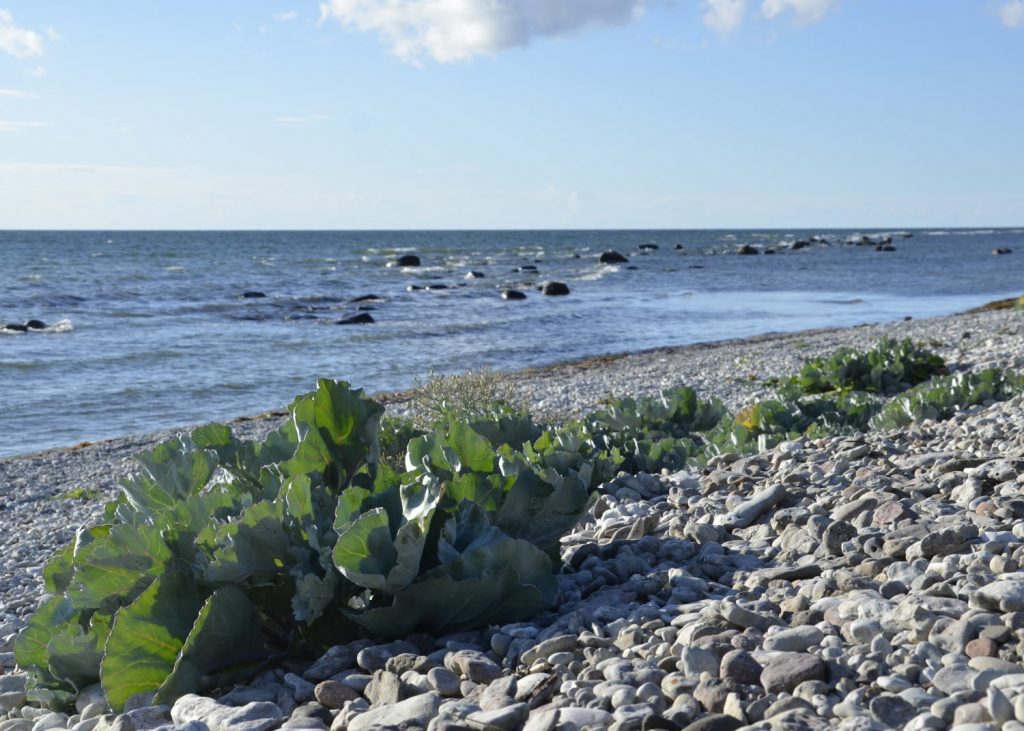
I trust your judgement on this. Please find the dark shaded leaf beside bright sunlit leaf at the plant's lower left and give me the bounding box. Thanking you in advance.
[156,586,267,704]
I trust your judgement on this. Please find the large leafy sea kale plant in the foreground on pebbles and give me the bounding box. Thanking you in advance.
[15,381,590,710]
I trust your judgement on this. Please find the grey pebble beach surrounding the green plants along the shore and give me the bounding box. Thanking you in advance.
[0,309,1024,731]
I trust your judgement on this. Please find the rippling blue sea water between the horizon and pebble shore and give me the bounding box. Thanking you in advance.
[0,229,1024,456]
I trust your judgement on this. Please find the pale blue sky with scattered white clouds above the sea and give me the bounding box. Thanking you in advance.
[0,0,1024,229]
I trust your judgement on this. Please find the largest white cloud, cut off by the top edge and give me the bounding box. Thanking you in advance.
[319,0,646,63]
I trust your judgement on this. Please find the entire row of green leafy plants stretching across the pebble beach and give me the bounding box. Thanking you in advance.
[15,341,1024,710]
